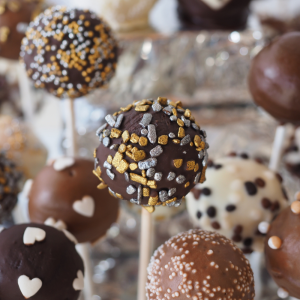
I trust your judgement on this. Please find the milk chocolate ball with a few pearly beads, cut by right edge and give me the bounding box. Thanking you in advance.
[265,193,300,299]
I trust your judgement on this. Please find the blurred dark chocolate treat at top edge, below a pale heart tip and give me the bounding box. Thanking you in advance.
[177,0,251,30]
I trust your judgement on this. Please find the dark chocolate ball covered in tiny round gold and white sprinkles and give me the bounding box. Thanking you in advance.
[20,6,117,98]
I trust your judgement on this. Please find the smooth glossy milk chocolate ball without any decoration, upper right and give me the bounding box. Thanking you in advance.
[249,32,300,125]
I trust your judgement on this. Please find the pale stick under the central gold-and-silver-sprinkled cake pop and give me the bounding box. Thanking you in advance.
[137,208,153,300]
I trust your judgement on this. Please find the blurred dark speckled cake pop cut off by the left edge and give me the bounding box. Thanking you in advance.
[0,152,21,223]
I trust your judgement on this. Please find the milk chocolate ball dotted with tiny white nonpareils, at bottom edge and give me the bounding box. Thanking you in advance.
[146,230,255,300]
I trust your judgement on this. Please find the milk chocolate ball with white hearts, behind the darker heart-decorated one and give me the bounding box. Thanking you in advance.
[28,157,119,243]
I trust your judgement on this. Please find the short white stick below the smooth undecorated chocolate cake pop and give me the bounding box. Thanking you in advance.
[269,125,286,172]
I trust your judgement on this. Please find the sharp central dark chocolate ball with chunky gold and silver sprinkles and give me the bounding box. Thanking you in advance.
[94,97,208,212]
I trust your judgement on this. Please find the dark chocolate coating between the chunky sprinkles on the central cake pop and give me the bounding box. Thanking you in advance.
[95,98,208,206]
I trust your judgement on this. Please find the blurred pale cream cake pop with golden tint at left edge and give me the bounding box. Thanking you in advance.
[0,116,48,179]
